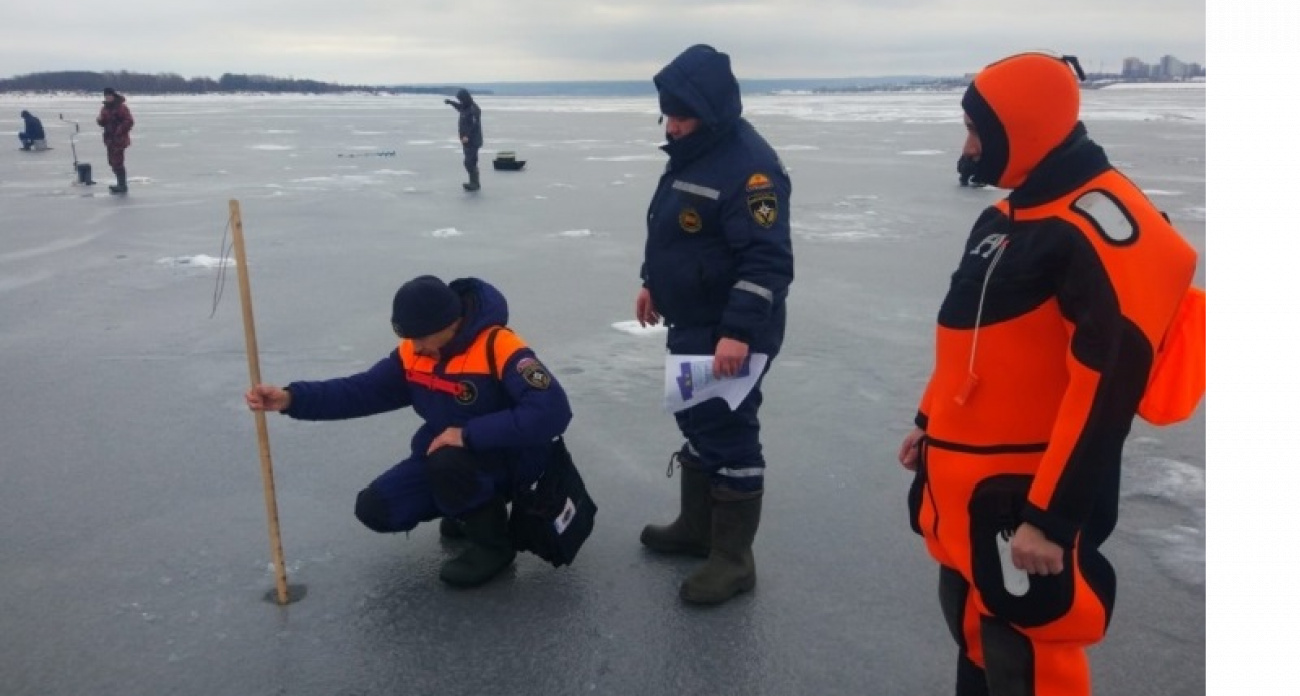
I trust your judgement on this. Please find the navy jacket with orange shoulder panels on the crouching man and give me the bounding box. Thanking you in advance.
[285,278,572,485]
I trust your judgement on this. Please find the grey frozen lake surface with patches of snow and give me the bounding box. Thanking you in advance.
[0,88,1206,696]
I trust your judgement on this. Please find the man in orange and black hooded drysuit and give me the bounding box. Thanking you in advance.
[898,53,1196,696]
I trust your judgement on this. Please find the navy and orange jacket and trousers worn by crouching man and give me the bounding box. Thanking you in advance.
[285,278,572,532]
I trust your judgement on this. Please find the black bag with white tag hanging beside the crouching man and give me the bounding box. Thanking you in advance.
[510,437,597,567]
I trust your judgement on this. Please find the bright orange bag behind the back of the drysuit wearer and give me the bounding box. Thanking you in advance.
[1138,288,1205,425]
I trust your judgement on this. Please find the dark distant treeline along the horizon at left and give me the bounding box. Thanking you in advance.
[0,70,473,94]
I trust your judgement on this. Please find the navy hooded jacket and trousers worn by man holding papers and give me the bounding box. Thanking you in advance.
[641,46,794,493]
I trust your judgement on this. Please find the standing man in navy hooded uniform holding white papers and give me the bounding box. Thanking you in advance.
[636,44,794,604]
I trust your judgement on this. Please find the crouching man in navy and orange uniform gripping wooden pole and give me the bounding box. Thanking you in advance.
[244,276,573,587]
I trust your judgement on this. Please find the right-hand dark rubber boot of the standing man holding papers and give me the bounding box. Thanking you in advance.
[681,493,763,604]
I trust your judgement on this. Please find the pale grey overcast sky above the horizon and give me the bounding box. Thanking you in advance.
[0,0,1205,85]
